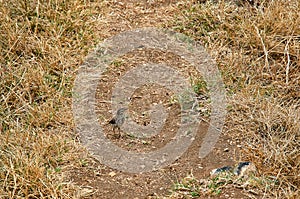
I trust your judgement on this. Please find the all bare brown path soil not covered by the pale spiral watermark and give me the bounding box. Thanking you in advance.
[70,0,259,199]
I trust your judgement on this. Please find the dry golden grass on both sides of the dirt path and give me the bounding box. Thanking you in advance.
[0,0,300,198]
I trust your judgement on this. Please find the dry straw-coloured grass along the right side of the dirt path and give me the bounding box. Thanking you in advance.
[172,0,300,198]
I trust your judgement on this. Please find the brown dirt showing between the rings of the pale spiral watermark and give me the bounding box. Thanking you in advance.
[96,50,204,152]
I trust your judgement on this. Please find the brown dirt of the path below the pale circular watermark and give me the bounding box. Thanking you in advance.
[72,123,241,198]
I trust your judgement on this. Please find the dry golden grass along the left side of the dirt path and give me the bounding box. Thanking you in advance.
[0,0,104,198]
